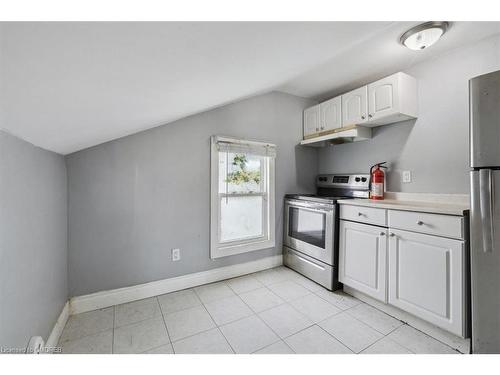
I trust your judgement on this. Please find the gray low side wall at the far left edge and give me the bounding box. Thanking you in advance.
[0,131,68,347]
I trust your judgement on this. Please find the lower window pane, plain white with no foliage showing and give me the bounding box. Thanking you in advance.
[220,196,264,242]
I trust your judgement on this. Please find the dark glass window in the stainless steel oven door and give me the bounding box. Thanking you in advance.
[288,207,326,249]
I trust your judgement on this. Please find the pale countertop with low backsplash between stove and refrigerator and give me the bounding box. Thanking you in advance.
[337,193,469,216]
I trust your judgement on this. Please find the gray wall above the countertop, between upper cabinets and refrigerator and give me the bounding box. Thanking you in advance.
[318,36,500,193]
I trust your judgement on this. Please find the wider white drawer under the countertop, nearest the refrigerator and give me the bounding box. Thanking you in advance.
[387,210,464,239]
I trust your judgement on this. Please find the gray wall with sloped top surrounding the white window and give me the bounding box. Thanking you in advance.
[66,92,317,296]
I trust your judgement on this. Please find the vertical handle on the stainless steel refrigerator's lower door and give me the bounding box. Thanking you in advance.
[479,169,495,253]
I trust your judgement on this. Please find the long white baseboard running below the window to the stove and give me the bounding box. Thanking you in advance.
[69,254,283,315]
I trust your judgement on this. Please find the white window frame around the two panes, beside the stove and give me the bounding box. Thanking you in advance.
[210,136,276,259]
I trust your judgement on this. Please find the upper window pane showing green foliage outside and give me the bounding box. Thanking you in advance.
[219,152,265,194]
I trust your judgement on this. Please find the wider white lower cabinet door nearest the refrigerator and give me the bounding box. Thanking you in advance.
[389,229,465,336]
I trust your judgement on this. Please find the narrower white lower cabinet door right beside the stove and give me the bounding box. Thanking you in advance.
[339,220,387,302]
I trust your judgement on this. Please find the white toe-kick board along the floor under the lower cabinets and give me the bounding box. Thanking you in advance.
[344,285,470,354]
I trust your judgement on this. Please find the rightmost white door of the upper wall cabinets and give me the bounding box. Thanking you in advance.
[368,74,399,121]
